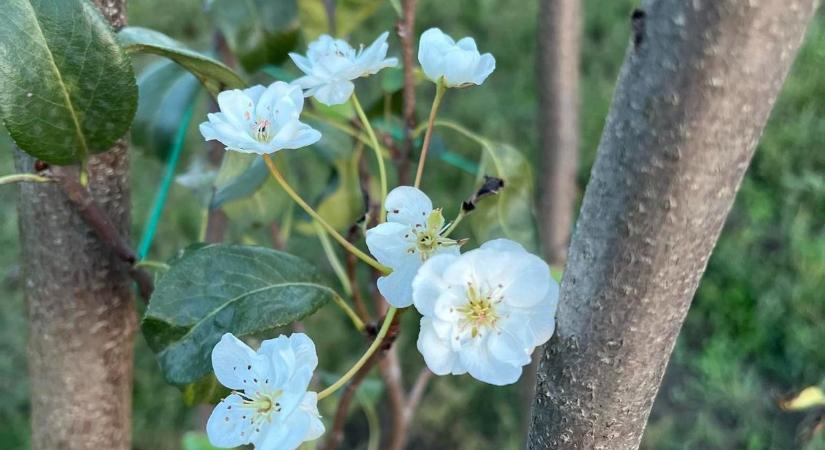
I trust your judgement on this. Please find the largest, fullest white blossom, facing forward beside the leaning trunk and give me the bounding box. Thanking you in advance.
[413,239,559,386]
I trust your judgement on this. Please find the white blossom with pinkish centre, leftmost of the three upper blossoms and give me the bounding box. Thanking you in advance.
[200,81,321,155]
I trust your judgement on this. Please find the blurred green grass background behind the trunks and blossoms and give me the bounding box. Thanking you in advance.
[0,0,825,450]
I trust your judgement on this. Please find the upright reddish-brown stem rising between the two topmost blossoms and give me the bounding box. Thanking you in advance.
[398,0,417,185]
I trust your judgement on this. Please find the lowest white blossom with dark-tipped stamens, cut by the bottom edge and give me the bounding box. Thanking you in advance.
[206,333,324,450]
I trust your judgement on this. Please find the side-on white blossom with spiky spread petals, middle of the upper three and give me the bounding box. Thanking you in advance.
[289,32,398,105]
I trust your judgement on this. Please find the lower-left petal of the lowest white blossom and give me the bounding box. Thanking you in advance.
[206,394,257,448]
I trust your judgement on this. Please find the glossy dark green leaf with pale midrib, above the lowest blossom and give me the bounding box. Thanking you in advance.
[142,245,334,384]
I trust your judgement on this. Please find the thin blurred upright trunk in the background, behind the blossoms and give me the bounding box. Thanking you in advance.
[537,0,581,266]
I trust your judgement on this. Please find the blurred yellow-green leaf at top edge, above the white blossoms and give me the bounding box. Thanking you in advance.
[298,0,384,41]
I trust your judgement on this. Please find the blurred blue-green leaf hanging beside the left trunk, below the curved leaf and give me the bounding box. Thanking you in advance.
[132,61,200,159]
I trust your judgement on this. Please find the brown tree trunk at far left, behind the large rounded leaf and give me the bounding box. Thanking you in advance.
[16,0,136,450]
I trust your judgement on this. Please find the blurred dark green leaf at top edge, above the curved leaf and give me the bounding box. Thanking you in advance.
[209,0,300,72]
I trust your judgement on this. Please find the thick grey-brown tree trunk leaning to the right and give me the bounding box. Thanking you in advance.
[528,0,817,450]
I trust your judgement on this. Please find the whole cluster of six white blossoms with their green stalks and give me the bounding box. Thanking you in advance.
[200,28,559,450]
